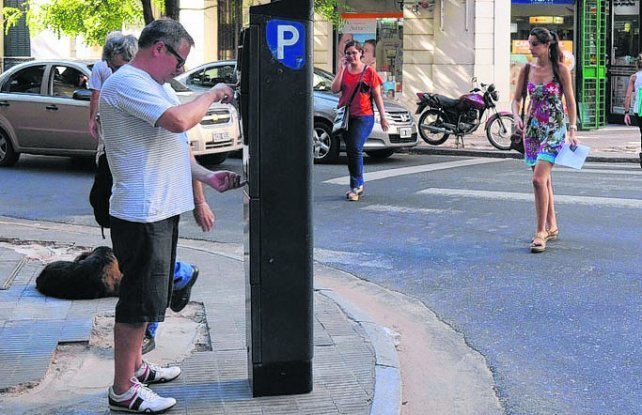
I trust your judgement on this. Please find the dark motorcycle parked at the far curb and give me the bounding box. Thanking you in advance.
[416,80,515,150]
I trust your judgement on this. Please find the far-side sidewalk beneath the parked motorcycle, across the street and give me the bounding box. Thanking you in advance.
[410,125,640,164]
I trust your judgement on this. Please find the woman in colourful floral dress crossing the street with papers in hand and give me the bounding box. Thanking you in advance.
[512,27,579,252]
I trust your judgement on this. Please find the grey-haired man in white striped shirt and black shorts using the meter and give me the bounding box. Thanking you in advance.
[100,19,240,413]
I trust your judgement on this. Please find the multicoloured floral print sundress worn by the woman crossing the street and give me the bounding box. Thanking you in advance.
[524,78,566,167]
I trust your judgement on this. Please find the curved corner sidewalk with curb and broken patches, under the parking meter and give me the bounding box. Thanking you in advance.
[0,217,502,415]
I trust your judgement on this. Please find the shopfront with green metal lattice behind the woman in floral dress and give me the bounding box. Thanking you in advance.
[511,0,640,129]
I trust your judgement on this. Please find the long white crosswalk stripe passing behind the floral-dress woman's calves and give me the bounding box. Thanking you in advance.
[417,188,642,208]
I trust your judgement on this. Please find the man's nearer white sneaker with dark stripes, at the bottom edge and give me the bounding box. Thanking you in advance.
[109,378,176,414]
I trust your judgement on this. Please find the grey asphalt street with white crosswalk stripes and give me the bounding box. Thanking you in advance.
[0,155,642,415]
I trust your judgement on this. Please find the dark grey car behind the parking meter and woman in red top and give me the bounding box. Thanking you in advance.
[176,60,418,163]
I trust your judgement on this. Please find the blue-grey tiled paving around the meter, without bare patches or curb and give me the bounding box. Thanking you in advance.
[0,248,375,415]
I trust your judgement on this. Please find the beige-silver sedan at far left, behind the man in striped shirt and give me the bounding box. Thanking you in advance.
[0,60,243,166]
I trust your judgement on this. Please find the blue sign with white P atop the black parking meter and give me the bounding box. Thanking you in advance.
[265,19,305,69]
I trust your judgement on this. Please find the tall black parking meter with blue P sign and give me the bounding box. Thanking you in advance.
[238,0,313,396]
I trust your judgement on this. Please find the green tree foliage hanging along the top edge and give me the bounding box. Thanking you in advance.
[3,0,345,46]
